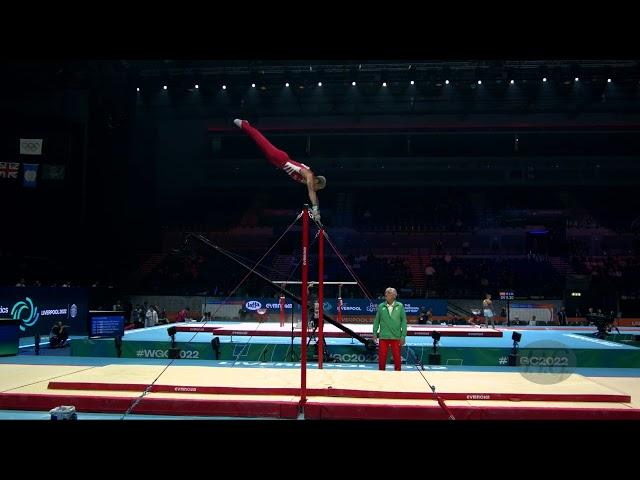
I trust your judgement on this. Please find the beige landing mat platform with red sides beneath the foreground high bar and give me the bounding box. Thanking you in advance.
[0,364,640,419]
